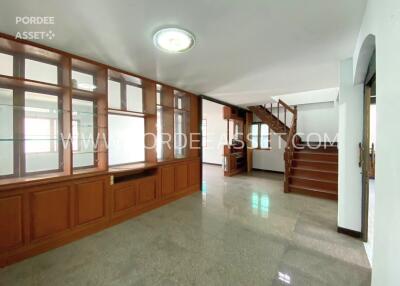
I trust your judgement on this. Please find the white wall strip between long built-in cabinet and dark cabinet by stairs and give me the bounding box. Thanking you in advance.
[203,100,227,165]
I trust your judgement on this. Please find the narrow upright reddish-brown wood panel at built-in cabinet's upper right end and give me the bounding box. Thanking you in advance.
[188,94,201,158]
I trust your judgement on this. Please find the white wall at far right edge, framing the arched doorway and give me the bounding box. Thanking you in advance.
[346,0,400,286]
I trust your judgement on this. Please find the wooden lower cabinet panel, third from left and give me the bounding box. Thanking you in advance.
[76,180,105,224]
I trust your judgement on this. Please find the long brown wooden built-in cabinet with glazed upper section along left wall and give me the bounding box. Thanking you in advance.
[0,33,201,267]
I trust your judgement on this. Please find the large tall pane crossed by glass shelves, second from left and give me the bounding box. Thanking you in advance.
[24,92,60,172]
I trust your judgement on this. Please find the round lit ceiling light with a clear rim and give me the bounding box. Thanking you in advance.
[153,28,195,53]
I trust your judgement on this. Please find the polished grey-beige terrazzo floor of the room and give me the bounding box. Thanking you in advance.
[0,165,370,286]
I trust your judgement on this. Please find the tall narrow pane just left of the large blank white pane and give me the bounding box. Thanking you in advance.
[72,98,97,168]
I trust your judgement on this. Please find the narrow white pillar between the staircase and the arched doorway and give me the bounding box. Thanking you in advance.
[338,59,363,231]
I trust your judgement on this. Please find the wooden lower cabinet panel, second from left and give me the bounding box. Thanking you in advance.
[30,187,71,240]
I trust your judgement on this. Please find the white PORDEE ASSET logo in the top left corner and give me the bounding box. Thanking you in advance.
[15,16,56,40]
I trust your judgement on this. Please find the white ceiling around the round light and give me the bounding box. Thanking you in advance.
[0,0,366,104]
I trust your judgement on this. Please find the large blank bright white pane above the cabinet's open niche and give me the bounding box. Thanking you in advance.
[108,114,145,165]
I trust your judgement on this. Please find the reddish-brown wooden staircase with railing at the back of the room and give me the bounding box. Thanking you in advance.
[249,100,338,200]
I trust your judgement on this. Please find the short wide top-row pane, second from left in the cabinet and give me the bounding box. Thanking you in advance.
[25,59,58,84]
